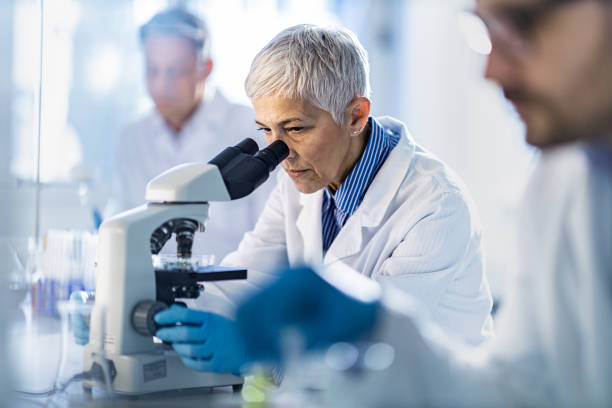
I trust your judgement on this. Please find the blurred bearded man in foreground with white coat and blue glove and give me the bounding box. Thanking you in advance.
[221,0,612,407]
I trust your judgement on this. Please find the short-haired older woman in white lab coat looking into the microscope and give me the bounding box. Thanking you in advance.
[156,25,491,372]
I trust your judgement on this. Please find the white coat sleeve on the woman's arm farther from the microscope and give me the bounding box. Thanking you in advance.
[374,192,492,344]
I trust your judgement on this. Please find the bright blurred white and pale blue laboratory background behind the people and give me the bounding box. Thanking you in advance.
[0,0,535,312]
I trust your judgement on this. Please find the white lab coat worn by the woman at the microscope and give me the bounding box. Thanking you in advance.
[195,117,491,343]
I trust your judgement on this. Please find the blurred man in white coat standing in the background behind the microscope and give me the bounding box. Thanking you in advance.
[106,8,266,260]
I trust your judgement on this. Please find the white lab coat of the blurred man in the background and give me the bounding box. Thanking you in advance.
[108,86,274,262]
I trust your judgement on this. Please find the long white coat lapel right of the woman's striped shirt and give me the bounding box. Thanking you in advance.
[326,127,415,265]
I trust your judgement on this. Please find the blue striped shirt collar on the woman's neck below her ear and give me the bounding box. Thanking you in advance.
[324,118,399,216]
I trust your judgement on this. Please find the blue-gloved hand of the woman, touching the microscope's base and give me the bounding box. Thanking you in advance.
[155,305,245,375]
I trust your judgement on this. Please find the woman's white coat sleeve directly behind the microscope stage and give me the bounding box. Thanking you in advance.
[192,174,288,317]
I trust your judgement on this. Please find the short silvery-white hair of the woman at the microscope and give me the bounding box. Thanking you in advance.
[245,24,370,126]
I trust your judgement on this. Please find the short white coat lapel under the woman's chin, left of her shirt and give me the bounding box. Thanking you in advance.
[296,190,323,265]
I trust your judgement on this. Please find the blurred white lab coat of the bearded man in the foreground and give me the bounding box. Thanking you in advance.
[340,139,612,407]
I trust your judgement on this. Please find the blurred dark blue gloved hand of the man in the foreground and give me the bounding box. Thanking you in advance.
[236,267,380,362]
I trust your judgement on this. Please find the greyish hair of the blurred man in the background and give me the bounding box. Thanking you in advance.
[138,8,210,62]
